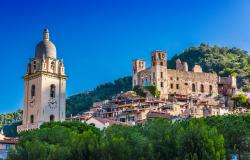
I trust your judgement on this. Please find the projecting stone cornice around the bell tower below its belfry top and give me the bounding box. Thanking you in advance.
[23,71,68,80]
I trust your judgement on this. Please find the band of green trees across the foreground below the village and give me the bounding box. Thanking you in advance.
[9,116,250,160]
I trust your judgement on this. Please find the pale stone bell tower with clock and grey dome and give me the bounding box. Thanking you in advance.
[18,29,67,132]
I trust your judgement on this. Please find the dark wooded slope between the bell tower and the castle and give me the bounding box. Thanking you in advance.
[66,77,132,116]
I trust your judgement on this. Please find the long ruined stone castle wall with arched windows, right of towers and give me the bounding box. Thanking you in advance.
[167,69,218,95]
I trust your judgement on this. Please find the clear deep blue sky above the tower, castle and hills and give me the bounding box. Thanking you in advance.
[0,0,250,113]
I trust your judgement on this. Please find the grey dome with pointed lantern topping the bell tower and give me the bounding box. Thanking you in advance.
[35,28,56,58]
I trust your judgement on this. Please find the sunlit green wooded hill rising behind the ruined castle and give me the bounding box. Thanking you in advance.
[168,44,250,91]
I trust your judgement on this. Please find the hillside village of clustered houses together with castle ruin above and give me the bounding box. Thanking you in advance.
[66,51,247,129]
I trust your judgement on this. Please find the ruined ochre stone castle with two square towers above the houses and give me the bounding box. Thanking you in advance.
[132,50,237,99]
